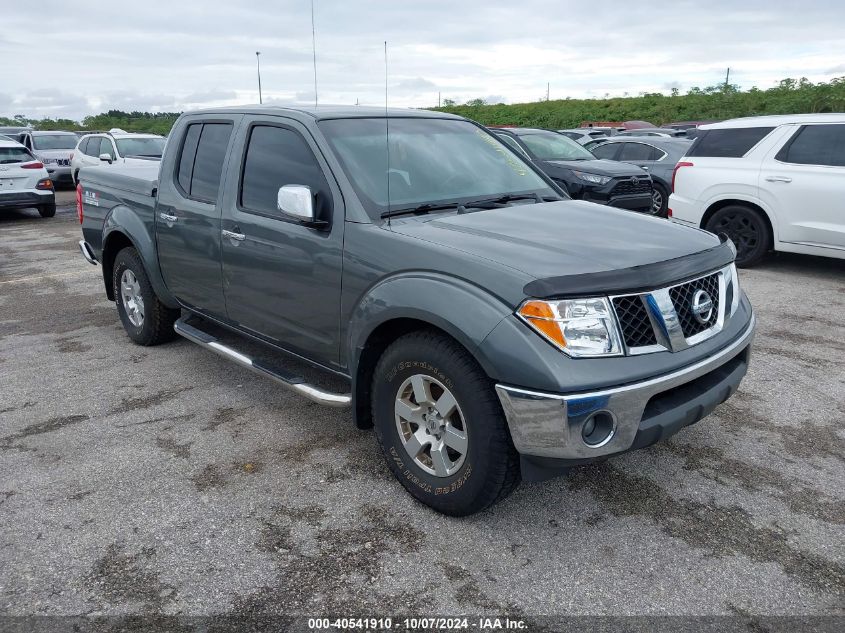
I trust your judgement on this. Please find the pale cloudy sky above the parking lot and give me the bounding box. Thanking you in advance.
[0,0,845,120]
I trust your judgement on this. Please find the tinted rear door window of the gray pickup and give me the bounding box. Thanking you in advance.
[176,123,232,203]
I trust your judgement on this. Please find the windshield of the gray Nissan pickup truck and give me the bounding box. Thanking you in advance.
[319,118,558,218]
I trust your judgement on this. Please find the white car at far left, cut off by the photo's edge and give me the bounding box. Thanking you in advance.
[0,140,56,218]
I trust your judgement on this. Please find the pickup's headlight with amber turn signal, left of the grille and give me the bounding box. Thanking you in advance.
[517,298,622,357]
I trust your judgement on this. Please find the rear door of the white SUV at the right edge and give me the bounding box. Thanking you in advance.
[760,122,845,248]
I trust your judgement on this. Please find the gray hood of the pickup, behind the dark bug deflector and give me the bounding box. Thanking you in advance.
[391,200,720,279]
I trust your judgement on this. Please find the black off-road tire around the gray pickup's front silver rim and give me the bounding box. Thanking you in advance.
[372,330,520,516]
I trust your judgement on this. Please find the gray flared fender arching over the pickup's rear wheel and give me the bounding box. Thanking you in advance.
[103,205,179,308]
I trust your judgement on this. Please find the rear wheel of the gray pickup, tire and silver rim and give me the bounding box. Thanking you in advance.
[112,247,180,345]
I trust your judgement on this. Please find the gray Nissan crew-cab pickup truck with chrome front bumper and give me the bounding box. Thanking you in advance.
[77,107,754,515]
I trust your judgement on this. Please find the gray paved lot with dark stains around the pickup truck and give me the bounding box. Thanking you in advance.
[0,192,845,615]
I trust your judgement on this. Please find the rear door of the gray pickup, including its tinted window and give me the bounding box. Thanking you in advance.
[155,115,242,318]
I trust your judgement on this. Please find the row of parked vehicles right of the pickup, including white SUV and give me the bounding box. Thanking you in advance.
[491,114,845,266]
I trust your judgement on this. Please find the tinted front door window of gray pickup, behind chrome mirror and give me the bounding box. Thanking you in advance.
[240,125,331,219]
